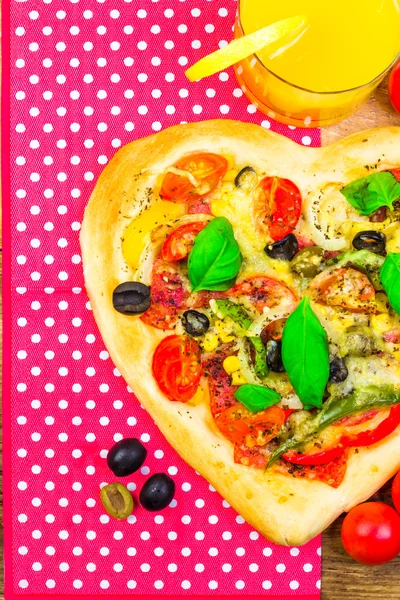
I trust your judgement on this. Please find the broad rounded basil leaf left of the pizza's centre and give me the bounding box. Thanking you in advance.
[188,217,242,292]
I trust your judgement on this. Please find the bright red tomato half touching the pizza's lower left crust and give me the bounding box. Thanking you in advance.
[153,335,202,402]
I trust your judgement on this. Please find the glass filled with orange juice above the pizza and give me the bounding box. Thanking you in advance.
[235,0,400,127]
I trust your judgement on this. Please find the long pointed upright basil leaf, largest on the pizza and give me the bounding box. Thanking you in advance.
[282,296,329,409]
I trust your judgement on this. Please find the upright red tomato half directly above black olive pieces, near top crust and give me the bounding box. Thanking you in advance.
[254,177,301,241]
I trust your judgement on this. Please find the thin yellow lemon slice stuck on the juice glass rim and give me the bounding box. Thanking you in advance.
[185,15,307,81]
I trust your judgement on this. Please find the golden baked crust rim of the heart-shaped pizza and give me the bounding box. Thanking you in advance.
[80,120,400,545]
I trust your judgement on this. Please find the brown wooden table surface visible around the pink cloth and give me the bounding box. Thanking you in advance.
[0,80,400,600]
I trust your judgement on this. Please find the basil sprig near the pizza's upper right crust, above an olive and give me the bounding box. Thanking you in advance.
[340,171,400,215]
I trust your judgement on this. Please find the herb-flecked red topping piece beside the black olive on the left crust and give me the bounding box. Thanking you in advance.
[140,258,189,330]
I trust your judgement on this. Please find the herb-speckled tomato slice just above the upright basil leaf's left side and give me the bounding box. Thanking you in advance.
[225,276,297,312]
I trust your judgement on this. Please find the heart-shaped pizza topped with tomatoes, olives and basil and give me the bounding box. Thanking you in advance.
[81,120,400,545]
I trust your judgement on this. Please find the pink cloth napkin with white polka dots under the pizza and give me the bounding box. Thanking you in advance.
[2,0,320,600]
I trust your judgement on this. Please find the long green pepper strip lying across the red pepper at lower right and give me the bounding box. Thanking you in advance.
[266,385,400,468]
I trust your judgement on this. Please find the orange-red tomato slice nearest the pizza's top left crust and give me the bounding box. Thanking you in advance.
[160,152,228,212]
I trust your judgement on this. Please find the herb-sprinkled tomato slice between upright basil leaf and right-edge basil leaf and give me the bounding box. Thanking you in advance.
[310,268,375,312]
